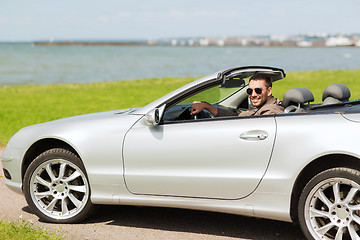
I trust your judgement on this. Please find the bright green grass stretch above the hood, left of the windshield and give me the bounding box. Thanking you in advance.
[0,78,195,145]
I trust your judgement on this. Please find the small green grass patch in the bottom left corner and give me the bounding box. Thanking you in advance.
[0,221,65,240]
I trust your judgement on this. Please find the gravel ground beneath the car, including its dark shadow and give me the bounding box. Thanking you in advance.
[0,147,304,240]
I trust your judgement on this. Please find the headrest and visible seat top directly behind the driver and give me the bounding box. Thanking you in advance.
[283,87,314,113]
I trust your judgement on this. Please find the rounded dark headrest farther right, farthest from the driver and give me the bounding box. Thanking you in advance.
[322,83,351,105]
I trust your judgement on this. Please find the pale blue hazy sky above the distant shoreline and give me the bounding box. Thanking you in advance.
[0,0,360,41]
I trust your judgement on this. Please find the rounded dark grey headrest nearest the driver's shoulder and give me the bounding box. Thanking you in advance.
[283,87,314,108]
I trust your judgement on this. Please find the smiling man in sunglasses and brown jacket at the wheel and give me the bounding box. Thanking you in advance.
[190,73,284,117]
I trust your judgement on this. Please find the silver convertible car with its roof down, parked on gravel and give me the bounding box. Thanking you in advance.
[1,66,360,240]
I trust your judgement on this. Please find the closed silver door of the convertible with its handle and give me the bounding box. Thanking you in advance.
[123,116,276,199]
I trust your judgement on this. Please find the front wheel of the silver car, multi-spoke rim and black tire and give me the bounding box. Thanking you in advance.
[23,148,93,223]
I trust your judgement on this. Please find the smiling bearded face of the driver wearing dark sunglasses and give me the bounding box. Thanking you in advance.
[249,79,272,108]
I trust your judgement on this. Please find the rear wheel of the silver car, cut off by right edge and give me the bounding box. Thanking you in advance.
[298,168,360,240]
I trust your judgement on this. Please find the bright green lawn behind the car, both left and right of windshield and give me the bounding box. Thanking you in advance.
[0,70,360,145]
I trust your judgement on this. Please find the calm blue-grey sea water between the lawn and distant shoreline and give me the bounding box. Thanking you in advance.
[0,43,360,85]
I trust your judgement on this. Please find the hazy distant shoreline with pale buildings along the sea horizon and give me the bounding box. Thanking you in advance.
[0,33,360,47]
